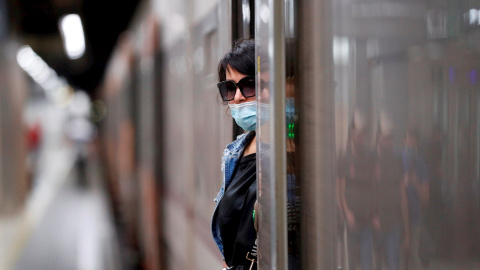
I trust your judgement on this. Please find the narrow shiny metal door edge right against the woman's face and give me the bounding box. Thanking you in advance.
[256,0,293,269]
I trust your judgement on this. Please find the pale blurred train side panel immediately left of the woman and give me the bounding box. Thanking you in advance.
[154,1,233,269]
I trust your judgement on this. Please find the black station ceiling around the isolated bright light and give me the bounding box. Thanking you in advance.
[6,0,142,94]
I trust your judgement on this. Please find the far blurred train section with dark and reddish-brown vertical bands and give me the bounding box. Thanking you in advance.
[98,7,161,269]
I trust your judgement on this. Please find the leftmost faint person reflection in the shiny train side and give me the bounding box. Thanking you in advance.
[337,112,378,270]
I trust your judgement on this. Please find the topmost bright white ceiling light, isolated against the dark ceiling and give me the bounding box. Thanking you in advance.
[60,14,85,59]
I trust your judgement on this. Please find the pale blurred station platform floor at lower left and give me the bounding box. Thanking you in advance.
[0,143,125,270]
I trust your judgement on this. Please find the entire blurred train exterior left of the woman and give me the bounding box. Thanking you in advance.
[101,1,253,269]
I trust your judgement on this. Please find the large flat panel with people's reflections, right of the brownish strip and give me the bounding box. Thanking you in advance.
[331,0,480,270]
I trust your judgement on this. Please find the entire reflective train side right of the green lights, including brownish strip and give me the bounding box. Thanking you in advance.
[294,1,480,269]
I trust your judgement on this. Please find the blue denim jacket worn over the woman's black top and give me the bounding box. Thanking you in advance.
[211,131,255,255]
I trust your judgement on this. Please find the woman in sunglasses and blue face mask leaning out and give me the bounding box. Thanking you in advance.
[212,40,257,270]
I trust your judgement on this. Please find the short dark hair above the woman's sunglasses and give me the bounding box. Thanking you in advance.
[218,39,255,81]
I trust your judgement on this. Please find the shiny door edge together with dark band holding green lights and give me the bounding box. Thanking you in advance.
[255,0,301,269]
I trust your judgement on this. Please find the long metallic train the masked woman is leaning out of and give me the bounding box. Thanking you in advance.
[93,0,480,270]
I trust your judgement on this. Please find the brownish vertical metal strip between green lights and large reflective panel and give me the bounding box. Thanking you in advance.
[298,0,336,269]
